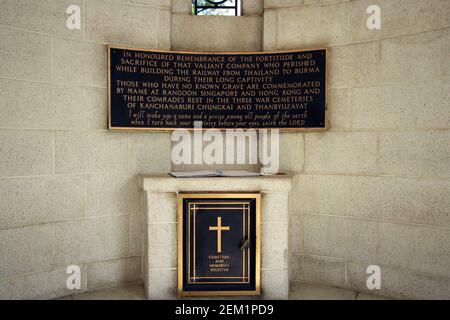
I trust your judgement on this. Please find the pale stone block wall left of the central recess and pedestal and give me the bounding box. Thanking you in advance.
[0,0,171,299]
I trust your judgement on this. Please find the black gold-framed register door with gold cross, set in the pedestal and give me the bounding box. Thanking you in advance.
[178,193,260,296]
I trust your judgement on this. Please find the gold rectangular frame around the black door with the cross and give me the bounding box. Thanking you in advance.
[177,192,261,297]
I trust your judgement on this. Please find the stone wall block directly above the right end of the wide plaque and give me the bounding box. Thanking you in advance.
[278,3,348,49]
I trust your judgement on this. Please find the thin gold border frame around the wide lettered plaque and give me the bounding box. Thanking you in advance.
[106,44,330,132]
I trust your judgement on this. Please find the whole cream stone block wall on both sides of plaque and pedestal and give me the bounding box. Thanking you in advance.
[0,0,450,298]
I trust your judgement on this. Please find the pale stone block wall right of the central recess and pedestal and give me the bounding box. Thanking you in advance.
[264,0,450,299]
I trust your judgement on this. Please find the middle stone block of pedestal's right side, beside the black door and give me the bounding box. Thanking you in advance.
[261,223,288,269]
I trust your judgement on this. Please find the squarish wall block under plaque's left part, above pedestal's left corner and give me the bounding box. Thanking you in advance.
[131,133,171,173]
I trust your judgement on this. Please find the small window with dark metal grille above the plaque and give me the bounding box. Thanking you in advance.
[192,0,241,16]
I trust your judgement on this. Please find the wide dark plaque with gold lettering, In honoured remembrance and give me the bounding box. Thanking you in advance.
[108,46,328,131]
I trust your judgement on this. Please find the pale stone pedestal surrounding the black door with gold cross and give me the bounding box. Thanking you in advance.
[139,174,291,299]
